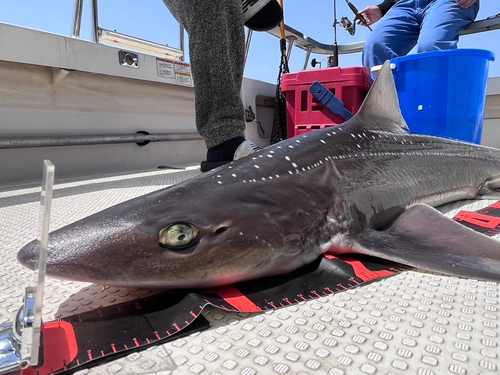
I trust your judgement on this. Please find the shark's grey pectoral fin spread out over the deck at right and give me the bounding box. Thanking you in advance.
[356,204,500,281]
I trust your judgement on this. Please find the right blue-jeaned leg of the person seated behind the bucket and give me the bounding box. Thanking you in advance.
[417,0,479,53]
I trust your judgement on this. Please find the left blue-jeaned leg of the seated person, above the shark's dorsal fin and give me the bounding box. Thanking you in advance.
[363,0,420,75]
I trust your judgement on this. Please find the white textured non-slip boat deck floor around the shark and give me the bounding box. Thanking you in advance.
[0,169,500,375]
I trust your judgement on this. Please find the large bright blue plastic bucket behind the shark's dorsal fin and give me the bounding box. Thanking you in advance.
[391,49,495,144]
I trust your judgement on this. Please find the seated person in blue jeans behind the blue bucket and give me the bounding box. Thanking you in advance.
[358,0,479,75]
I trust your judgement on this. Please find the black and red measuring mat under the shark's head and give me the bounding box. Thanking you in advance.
[5,256,408,375]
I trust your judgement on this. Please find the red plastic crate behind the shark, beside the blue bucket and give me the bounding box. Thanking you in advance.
[281,67,373,138]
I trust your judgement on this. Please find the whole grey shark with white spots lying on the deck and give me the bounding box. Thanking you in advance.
[18,63,500,288]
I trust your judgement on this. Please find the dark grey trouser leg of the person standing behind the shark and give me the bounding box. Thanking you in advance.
[163,0,245,148]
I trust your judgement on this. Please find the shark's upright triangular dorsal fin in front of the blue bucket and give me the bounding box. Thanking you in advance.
[354,60,408,133]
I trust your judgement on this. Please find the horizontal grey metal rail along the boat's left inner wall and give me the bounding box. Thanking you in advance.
[0,133,204,150]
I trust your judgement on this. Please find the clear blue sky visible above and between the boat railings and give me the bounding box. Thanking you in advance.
[0,0,500,83]
